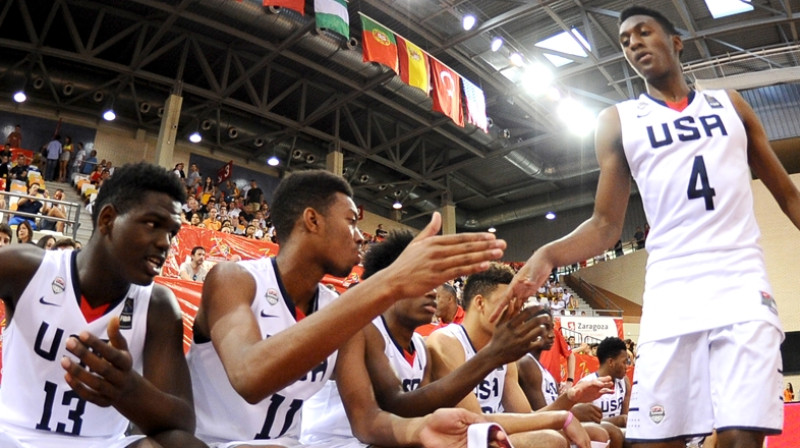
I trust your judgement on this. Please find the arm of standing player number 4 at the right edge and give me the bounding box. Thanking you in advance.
[728,90,800,229]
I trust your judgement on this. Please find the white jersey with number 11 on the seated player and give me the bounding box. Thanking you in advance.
[187,258,337,442]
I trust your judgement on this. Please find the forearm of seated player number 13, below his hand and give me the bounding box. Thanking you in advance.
[114,373,195,435]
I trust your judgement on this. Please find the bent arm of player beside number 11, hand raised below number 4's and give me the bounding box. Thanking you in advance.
[367,307,544,417]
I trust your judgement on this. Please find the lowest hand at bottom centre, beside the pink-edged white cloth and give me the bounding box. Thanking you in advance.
[419,408,509,448]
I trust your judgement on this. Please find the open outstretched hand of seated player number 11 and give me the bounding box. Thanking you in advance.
[376,213,506,298]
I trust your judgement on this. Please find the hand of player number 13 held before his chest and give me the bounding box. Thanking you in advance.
[61,317,139,407]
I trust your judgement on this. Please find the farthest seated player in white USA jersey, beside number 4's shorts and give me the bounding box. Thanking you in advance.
[578,337,631,428]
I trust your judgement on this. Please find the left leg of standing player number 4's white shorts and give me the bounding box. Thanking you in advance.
[625,332,714,448]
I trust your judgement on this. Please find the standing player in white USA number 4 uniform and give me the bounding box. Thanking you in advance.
[495,7,800,448]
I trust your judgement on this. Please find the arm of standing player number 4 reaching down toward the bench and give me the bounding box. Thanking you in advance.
[492,106,631,318]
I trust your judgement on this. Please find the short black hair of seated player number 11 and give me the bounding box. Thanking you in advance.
[271,170,353,244]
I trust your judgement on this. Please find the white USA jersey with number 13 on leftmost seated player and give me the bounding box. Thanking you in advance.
[0,251,153,440]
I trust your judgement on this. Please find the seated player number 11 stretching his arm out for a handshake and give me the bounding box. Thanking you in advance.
[184,171,505,447]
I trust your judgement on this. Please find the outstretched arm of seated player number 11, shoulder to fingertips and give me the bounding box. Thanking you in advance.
[199,213,505,403]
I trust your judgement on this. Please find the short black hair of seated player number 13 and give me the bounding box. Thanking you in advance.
[92,162,186,229]
